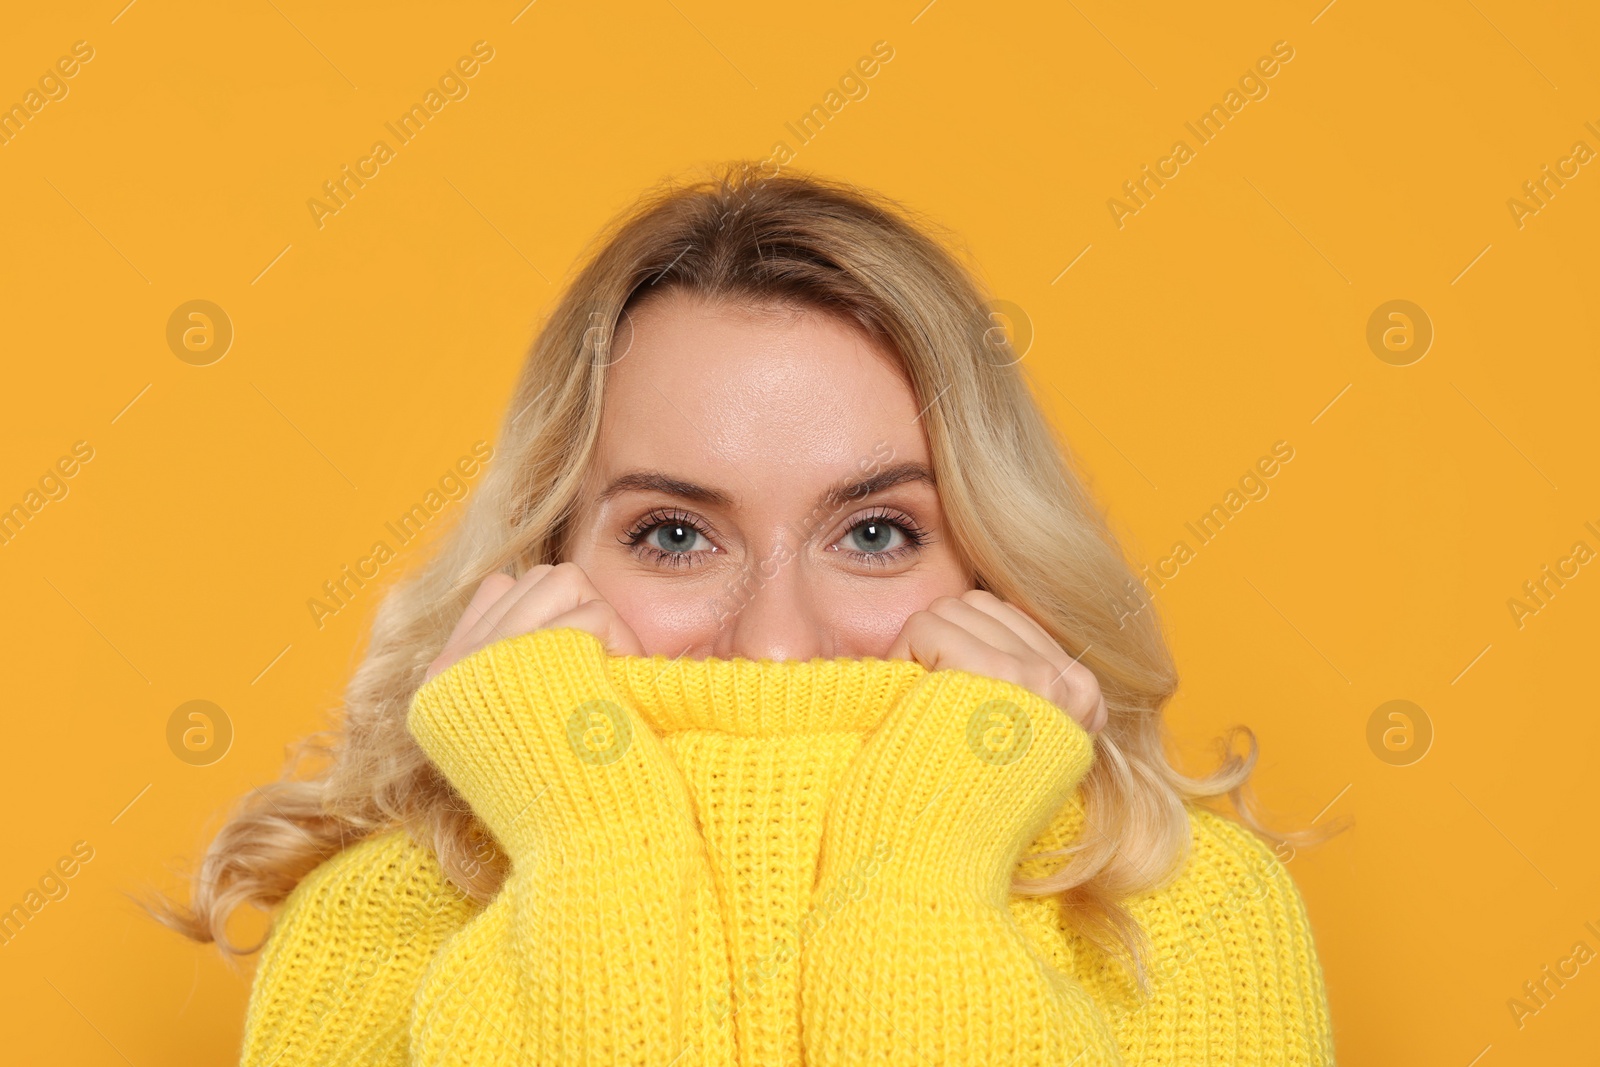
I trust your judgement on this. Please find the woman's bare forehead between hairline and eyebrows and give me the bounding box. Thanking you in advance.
[597,293,928,496]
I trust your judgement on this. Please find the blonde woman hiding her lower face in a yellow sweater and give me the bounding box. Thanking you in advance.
[150,163,1333,1067]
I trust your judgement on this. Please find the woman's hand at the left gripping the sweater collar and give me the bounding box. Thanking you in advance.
[422,561,645,681]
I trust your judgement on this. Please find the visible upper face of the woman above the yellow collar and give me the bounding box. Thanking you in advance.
[562,290,973,659]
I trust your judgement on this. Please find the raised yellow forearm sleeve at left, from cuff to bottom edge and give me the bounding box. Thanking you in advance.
[406,627,736,1067]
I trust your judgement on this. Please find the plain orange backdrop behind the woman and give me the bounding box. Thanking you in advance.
[0,0,1600,1067]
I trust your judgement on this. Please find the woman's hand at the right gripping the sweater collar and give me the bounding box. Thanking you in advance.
[886,589,1110,734]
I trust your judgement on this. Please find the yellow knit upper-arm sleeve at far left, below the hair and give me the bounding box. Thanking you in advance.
[240,829,478,1067]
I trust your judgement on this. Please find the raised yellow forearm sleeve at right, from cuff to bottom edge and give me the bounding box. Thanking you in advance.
[802,669,1122,1067]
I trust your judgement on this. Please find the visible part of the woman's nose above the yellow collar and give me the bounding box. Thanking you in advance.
[717,526,829,659]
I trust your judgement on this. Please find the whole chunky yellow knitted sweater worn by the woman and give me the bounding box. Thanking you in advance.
[242,627,1333,1067]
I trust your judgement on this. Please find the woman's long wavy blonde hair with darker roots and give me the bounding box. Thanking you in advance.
[139,162,1331,989]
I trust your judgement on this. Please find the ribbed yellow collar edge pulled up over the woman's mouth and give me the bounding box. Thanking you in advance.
[606,654,928,737]
